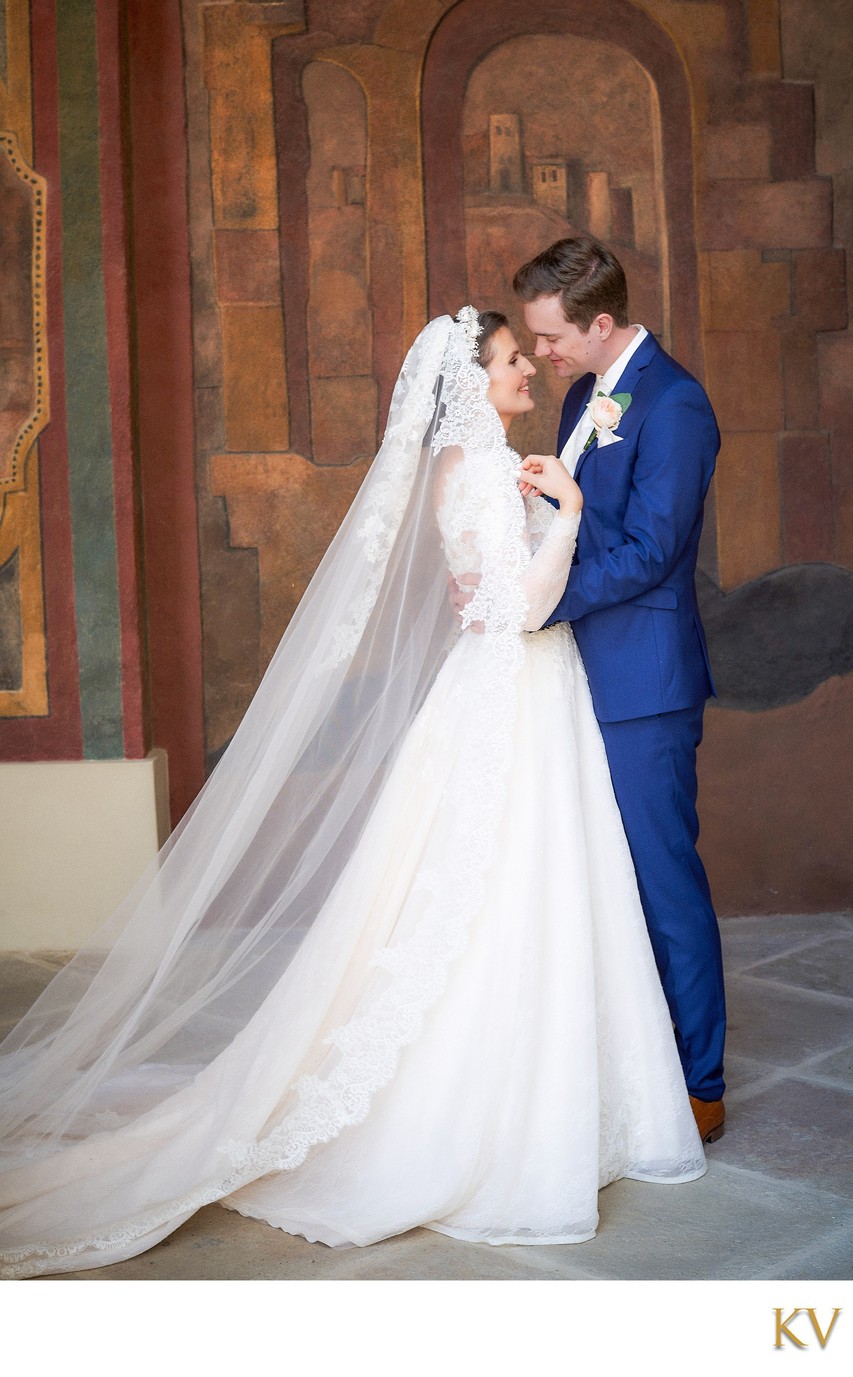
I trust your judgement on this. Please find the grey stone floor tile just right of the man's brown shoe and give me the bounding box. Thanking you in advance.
[715,1075,853,1200]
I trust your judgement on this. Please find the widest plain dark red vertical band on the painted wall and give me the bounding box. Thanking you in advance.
[127,0,204,821]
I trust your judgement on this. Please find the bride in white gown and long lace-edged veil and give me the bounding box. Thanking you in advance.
[0,307,706,1276]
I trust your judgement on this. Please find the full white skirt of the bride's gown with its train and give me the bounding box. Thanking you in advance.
[0,625,706,1275]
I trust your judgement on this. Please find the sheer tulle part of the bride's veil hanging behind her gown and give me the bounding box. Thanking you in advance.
[0,307,503,1164]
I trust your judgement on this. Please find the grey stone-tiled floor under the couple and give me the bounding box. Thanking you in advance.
[0,914,853,1281]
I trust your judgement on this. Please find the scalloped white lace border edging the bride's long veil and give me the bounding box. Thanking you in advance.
[0,315,540,1278]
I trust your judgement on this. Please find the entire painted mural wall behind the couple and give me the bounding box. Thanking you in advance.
[0,0,853,945]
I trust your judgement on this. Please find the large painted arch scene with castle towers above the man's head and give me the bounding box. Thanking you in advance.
[459,34,670,452]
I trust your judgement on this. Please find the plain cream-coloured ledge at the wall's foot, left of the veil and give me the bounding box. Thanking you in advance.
[0,750,169,952]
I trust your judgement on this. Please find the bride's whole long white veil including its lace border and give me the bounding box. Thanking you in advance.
[0,307,542,1275]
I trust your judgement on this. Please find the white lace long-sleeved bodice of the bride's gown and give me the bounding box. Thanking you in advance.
[435,449,580,632]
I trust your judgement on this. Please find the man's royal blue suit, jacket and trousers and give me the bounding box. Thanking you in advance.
[547,335,725,1100]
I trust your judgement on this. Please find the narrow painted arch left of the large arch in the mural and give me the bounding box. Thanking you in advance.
[273,43,376,464]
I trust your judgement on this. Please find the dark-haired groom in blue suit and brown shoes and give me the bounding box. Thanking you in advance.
[513,234,725,1142]
